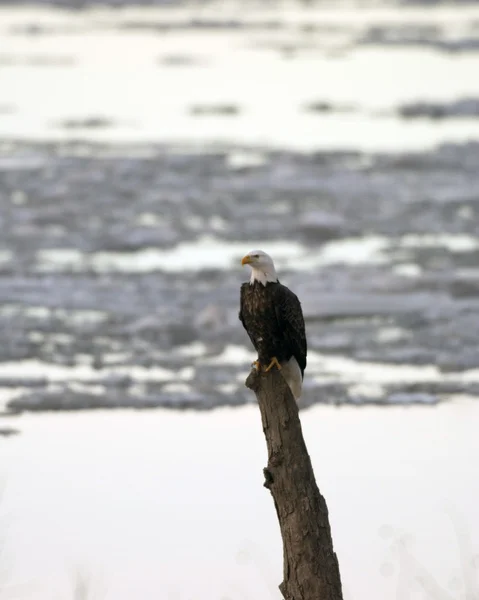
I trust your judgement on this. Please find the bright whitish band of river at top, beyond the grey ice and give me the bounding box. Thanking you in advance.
[0,2,479,151]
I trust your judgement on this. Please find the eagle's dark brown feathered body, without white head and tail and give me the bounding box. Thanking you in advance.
[239,281,307,376]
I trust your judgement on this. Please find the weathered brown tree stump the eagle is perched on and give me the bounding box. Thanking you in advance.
[246,369,343,600]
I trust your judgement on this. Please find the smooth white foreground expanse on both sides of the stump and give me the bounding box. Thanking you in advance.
[0,398,479,600]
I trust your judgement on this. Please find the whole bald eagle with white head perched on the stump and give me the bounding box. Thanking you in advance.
[239,250,307,400]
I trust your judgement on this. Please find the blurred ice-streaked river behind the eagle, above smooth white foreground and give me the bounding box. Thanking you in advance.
[0,3,479,410]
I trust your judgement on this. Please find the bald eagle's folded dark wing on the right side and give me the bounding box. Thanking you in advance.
[275,284,308,375]
